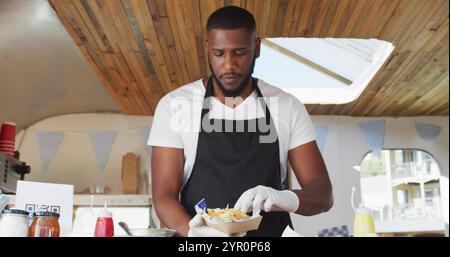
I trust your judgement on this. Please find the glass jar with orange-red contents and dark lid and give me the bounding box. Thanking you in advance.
[28,212,60,237]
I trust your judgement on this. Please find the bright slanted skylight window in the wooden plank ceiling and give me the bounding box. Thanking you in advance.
[254,38,394,104]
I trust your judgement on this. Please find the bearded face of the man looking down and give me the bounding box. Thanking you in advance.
[205,28,261,97]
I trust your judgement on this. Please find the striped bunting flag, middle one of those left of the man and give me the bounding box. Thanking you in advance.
[89,131,117,172]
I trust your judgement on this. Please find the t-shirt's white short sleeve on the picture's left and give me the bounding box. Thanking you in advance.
[147,95,184,149]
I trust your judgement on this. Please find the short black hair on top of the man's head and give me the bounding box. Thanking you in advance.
[206,6,256,33]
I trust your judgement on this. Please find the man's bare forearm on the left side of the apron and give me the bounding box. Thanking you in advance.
[154,196,191,236]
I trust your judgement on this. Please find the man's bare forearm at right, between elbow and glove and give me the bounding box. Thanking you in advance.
[292,181,333,216]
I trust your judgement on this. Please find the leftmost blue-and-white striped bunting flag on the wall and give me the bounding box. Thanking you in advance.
[36,132,64,172]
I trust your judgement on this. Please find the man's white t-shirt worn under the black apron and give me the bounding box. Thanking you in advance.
[147,79,315,186]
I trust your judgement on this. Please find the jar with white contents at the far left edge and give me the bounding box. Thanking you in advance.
[0,209,28,237]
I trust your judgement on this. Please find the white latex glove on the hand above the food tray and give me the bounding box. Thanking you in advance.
[234,186,300,215]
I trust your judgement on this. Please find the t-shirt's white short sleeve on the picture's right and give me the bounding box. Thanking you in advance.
[289,97,316,150]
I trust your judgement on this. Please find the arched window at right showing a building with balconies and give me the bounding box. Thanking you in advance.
[355,149,442,227]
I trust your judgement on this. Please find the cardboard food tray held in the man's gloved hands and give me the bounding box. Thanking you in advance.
[202,215,262,234]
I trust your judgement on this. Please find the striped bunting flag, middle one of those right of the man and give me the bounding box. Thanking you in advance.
[359,120,385,157]
